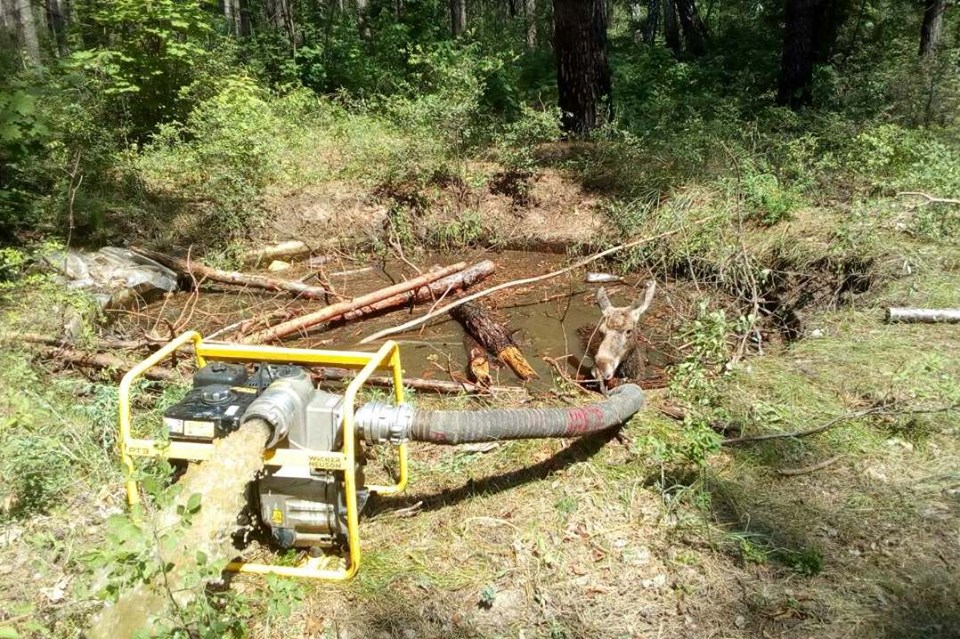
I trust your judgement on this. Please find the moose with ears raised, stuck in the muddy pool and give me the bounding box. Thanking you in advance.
[579,280,657,382]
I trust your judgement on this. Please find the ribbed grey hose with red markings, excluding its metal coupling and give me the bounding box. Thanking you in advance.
[409,384,643,445]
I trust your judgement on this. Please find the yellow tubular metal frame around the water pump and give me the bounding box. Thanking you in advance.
[119,331,407,581]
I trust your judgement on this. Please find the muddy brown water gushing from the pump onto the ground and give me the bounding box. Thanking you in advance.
[88,420,270,639]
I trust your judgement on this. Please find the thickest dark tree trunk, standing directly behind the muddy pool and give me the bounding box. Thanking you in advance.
[553,0,610,134]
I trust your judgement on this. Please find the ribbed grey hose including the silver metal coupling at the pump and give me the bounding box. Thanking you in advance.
[356,384,644,446]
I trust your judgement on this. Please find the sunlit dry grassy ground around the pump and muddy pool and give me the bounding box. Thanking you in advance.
[0,156,960,639]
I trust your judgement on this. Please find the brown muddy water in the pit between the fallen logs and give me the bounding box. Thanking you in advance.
[113,250,677,390]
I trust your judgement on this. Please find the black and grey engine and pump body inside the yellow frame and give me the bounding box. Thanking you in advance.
[163,362,369,548]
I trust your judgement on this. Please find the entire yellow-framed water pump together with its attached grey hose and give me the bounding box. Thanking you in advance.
[119,332,643,580]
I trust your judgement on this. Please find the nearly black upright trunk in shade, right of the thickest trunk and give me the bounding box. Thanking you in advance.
[777,0,830,109]
